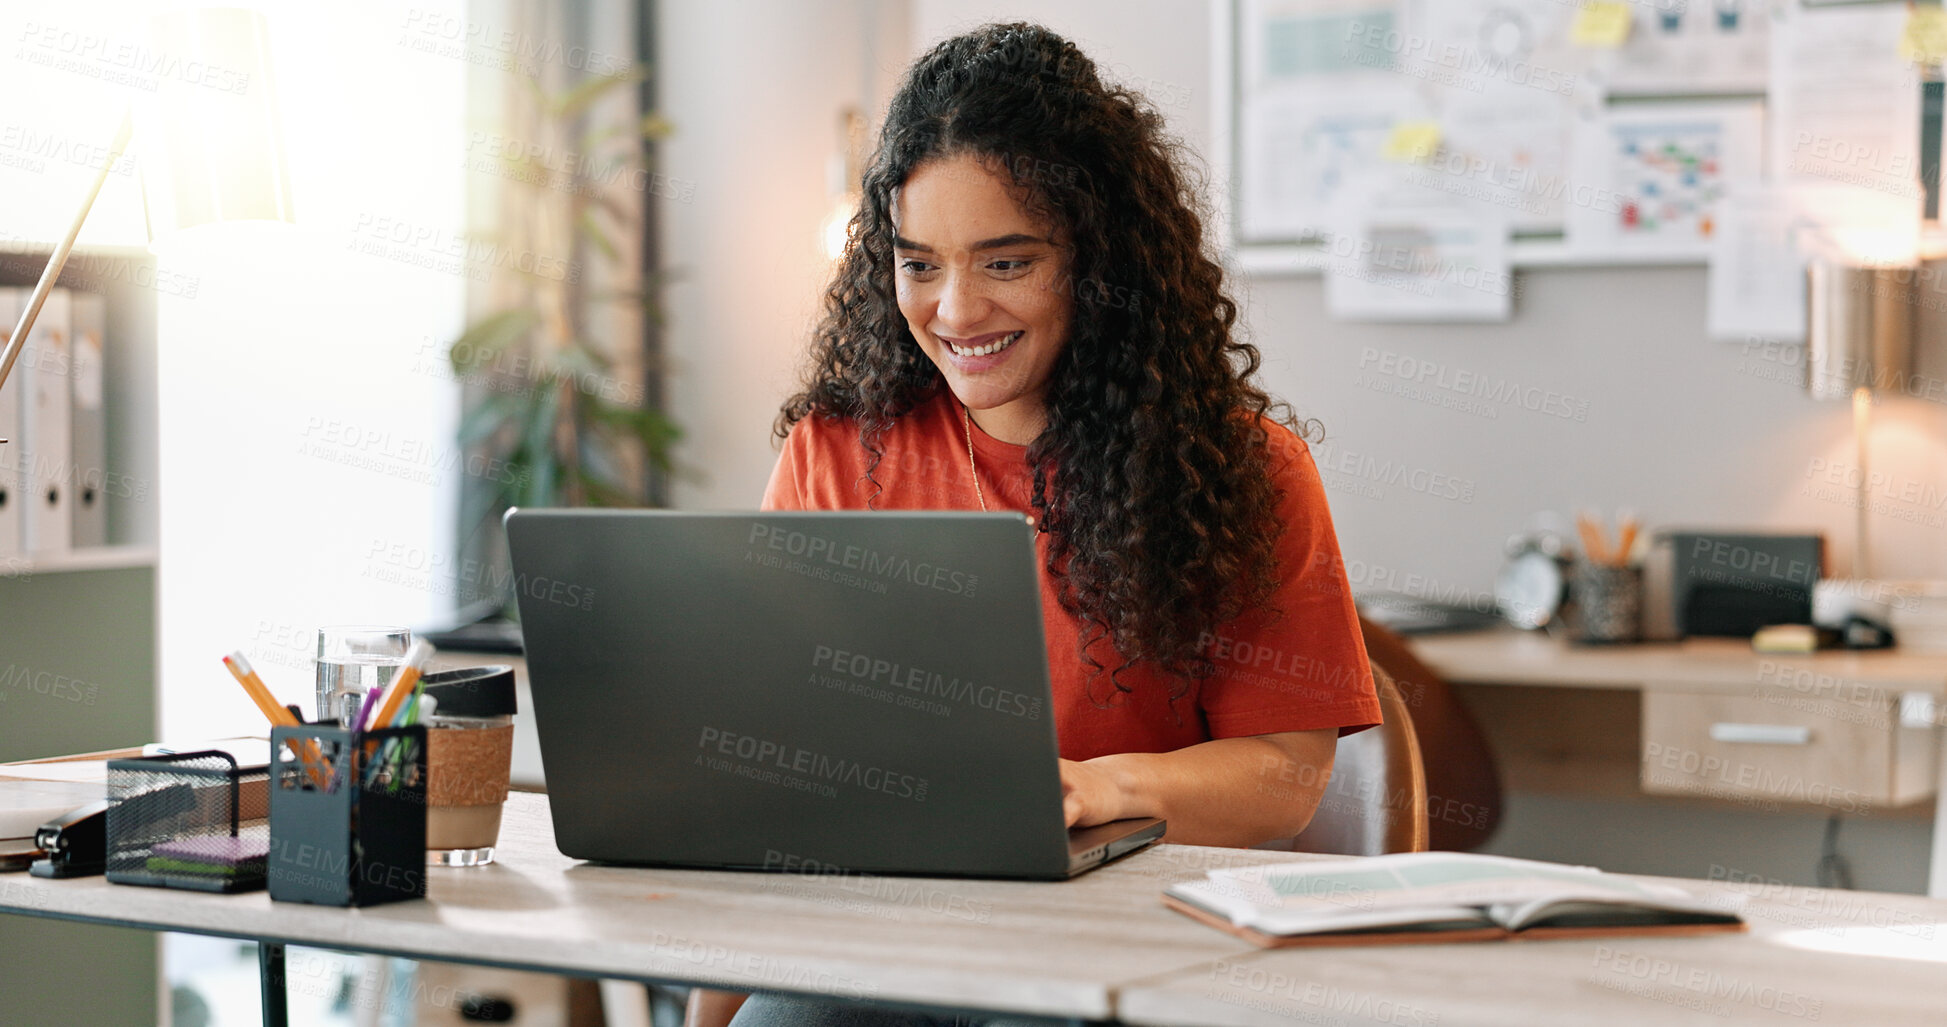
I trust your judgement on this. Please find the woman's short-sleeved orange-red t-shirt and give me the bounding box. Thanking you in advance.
[763,390,1380,760]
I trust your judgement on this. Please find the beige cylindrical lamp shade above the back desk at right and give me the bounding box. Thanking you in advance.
[1805,259,1916,399]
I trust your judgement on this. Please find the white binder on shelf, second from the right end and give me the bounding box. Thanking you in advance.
[14,288,74,555]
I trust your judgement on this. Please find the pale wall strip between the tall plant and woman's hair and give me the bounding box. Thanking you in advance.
[656,0,907,509]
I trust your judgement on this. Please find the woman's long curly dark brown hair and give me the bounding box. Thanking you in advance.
[777,23,1312,700]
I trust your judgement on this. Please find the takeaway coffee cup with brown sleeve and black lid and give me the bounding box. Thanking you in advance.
[422,665,516,867]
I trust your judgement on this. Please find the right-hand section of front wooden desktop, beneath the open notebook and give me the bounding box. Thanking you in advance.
[1118,881,1947,1027]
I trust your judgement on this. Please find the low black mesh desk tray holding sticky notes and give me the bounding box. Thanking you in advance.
[105,750,269,893]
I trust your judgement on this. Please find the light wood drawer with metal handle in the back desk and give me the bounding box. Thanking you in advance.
[1641,690,1935,815]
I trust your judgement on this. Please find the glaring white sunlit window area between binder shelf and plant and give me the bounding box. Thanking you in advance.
[158,0,467,739]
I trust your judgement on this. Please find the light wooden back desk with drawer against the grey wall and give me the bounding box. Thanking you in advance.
[1414,628,1947,896]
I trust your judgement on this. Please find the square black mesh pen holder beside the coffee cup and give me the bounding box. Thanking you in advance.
[269,725,426,906]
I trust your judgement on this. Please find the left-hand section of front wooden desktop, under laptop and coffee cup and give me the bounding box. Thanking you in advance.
[0,793,1253,1019]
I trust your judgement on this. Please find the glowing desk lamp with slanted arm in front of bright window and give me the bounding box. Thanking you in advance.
[0,8,292,442]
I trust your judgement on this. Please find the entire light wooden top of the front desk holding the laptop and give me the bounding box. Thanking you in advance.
[11,793,1947,1027]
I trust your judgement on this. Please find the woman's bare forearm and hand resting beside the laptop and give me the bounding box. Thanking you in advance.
[1079,729,1338,846]
